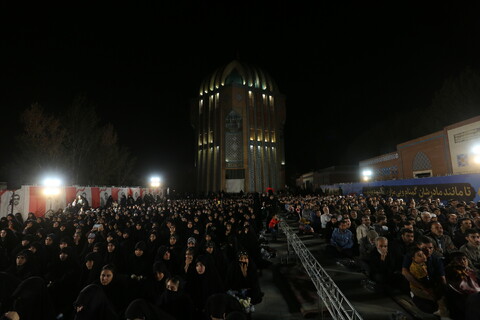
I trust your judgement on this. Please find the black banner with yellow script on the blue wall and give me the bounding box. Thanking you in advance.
[362,183,475,202]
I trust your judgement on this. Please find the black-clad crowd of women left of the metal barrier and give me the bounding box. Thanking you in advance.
[0,193,280,320]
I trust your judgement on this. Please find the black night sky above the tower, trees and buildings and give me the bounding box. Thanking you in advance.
[0,0,480,189]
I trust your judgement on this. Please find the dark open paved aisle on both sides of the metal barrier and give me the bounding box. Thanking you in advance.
[252,212,442,320]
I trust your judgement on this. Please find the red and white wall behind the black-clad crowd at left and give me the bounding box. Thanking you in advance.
[0,185,164,218]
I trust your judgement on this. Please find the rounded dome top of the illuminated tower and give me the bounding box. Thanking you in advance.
[200,60,278,95]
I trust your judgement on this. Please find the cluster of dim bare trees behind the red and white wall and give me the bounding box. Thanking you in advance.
[4,96,135,185]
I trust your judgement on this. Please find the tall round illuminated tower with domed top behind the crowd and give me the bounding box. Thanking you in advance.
[191,60,285,192]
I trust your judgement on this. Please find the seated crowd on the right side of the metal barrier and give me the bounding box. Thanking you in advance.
[280,195,480,319]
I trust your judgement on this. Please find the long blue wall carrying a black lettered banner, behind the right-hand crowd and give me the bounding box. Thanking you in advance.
[321,174,480,202]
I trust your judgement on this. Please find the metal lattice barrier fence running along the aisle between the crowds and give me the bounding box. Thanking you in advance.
[279,221,362,320]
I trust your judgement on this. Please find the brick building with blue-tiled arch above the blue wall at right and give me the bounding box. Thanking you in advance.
[359,116,480,181]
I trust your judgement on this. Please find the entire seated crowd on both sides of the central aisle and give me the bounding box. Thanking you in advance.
[0,189,480,320]
